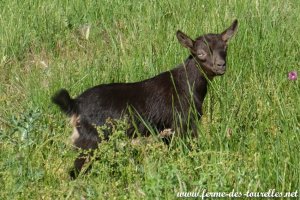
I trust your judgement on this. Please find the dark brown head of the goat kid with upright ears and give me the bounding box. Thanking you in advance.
[176,20,238,76]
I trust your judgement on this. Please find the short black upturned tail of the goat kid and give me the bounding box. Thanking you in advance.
[51,89,77,116]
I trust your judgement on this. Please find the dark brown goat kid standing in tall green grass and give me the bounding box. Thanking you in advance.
[52,20,238,178]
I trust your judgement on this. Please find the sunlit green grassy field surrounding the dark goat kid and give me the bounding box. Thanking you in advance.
[0,0,300,199]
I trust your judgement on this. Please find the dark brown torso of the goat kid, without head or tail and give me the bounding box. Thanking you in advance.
[68,58,207,141]
